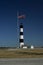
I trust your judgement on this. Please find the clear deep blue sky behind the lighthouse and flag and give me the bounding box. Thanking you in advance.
[0,0,43,46]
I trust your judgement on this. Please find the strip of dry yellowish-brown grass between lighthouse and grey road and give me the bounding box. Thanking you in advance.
[0,49,43,58]
